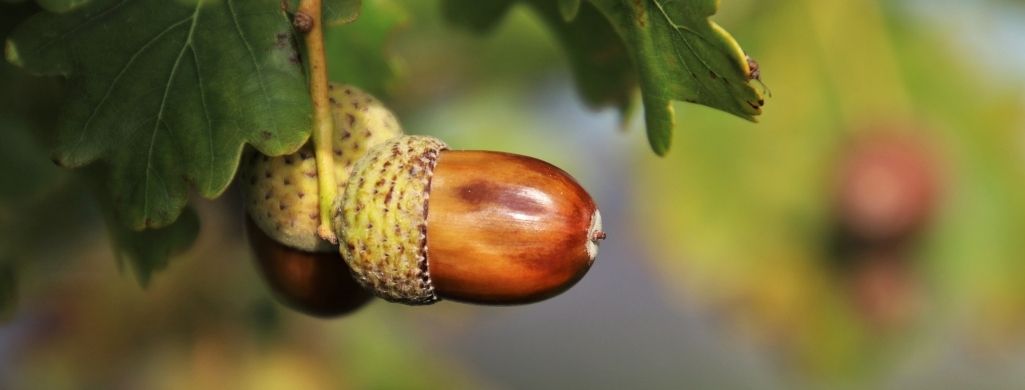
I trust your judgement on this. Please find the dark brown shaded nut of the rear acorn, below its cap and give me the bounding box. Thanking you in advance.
[246,217,373,317]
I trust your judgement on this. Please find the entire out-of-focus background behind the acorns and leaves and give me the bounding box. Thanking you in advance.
[0,0,1025,389]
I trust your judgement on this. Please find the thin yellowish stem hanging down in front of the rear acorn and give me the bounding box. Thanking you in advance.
[296,0,338,243]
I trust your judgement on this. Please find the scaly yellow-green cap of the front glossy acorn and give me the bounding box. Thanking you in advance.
[334,135,447,305]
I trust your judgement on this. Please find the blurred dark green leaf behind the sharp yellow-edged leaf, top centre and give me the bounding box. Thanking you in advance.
[443,0,637,117]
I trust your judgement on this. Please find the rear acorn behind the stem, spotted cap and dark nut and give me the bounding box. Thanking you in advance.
[241,84,402,317]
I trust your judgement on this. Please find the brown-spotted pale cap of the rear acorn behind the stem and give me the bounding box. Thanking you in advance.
[242,84,402,251]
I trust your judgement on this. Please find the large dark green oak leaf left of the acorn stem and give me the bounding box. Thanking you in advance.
[5,0,311,230]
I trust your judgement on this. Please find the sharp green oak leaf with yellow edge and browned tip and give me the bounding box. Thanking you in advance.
[591,0,764,155]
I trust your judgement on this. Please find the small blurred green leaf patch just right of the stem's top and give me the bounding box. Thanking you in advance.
[324,0,409,96]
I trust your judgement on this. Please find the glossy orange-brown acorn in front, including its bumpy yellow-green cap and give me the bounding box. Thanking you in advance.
[333,135,605,305]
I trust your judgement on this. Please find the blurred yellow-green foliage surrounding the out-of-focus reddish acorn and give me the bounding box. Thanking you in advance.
[634,0,1025,387]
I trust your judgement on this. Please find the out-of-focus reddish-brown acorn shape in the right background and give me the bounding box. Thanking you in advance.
[829,123,941,330]
